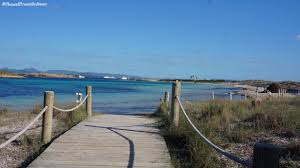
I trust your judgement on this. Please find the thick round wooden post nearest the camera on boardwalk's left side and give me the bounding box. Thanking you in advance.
[42,91,54,144]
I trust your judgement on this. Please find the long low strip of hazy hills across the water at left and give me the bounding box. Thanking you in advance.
[0,68,144,80]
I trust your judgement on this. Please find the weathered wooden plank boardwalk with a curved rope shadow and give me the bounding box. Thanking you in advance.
[29,115,171,168]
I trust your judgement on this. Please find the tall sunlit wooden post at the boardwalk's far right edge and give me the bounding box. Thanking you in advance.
[171,80,180,127]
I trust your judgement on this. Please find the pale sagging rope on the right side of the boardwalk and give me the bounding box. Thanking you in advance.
[176,96,251,167]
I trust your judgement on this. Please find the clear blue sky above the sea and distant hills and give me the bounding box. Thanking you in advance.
[0,0,300,81]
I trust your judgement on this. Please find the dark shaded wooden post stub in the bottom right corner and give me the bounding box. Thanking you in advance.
[253,143,280,168]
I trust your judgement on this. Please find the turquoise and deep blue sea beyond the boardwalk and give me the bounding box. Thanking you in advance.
[0,78,241,114]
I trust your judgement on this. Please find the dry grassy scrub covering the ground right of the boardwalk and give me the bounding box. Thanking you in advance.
[155,97,300,168]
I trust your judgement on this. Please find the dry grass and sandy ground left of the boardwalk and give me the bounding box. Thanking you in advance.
[0,104,87,167]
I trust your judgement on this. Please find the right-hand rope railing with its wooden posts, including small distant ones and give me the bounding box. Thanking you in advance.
[164,80,280,168]
